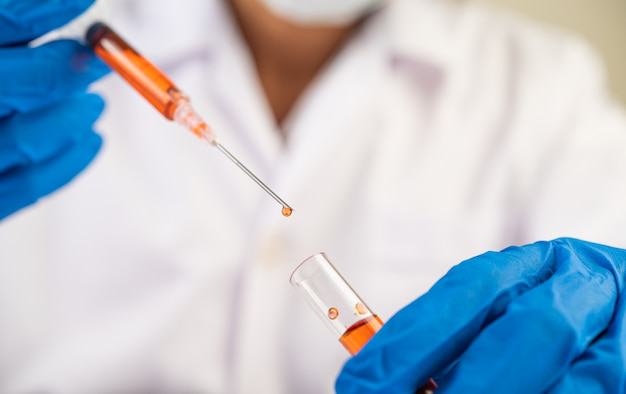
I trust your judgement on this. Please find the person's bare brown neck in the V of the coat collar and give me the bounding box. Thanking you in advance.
[230,0,357,131]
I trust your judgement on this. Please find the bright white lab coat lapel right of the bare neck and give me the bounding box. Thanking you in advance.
[277,21,386,209]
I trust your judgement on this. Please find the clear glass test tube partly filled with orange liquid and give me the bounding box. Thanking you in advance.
[289,253,437,394]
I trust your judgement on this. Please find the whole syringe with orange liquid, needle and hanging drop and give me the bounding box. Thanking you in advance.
[86,22,293,216]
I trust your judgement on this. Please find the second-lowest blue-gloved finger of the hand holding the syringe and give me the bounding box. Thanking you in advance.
[0,94,104,173]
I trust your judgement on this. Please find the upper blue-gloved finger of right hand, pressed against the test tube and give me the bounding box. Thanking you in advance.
[336,239,624,393]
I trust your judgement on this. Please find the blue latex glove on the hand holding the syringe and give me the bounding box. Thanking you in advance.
[0,0,108,219]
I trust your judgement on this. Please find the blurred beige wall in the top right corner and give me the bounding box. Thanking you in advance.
[474,0,626,106]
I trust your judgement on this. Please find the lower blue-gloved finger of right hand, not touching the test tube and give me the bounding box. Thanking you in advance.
[432,245,619,394]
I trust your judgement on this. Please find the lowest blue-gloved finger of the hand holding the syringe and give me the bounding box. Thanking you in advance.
[0,133,102,219]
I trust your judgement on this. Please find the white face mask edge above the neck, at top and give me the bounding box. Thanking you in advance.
[259,0,385,26]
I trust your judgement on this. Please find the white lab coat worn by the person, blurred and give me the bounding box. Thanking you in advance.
[0,0,626,394]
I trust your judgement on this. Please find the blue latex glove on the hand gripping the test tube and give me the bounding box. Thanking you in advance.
[336,239,626,394]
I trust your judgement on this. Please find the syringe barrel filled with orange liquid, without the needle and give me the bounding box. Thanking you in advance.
[86,22,183,120]
